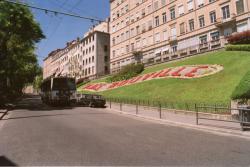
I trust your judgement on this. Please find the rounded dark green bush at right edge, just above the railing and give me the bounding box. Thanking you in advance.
[231,71,250,100]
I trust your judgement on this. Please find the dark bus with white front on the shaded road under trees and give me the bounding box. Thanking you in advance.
[40,77,76,105]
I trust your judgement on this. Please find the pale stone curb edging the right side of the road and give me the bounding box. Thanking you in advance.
[106,108,250,140]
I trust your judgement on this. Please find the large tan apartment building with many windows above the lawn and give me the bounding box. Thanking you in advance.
[110,0,250,73]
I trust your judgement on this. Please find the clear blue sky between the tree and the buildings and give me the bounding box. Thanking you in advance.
[22,0,110,66]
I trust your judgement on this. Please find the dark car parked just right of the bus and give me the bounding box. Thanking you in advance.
[76,94,106,107]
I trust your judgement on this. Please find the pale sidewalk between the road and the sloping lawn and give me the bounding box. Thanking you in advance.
[107,102,250,139]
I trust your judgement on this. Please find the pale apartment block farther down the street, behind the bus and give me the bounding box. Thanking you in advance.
[43,20,110,80]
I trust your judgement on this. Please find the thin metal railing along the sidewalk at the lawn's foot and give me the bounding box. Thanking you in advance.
[106,98,250,130]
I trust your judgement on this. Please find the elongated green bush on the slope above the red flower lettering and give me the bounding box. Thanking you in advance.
[106,64,144,83]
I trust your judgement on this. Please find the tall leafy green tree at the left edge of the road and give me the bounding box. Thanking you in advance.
[0,1,45,100]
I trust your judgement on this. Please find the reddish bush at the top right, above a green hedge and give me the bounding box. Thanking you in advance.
[227,30,250,44]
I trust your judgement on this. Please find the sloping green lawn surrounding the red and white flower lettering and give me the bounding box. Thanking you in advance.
[78,51,250,104]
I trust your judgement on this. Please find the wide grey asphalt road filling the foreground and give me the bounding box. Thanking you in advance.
[0,97,250,166]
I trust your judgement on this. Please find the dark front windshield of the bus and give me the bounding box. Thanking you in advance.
[52,78,76,90]
